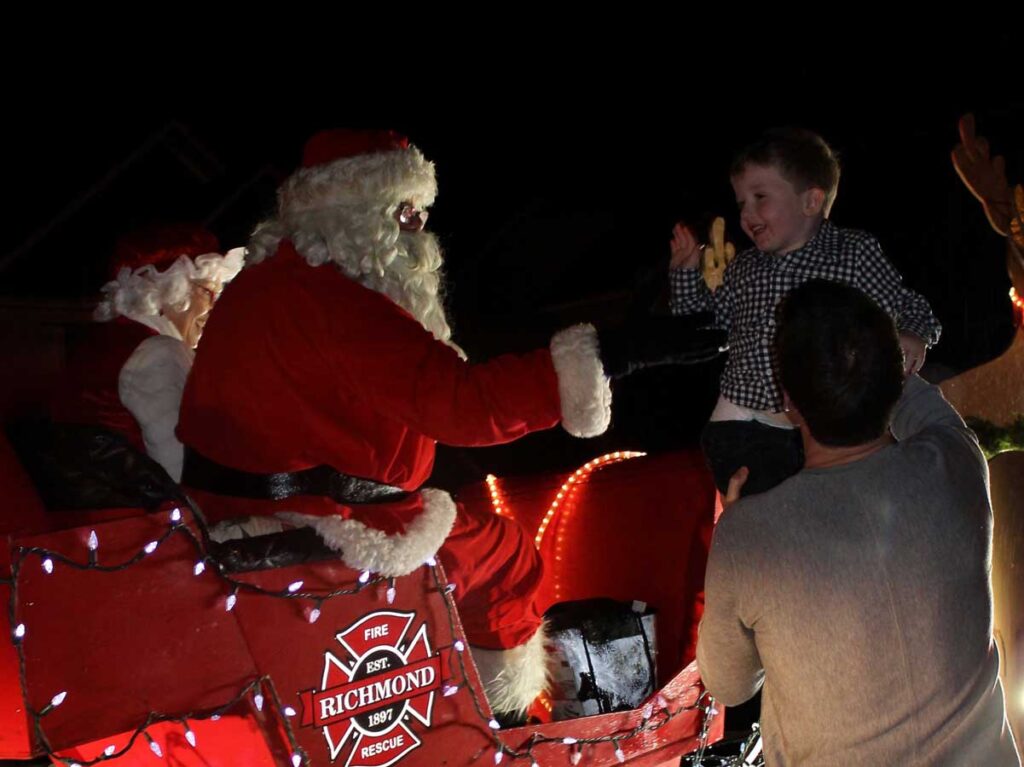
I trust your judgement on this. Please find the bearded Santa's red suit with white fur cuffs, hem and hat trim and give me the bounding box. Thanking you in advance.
[178,133,610,711]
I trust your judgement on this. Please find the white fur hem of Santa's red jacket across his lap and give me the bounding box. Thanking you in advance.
[276,487,456,578]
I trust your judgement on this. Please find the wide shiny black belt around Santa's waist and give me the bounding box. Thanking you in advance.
[181,448,409,505]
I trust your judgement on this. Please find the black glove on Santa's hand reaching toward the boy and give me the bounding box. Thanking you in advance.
[597,313,728,378]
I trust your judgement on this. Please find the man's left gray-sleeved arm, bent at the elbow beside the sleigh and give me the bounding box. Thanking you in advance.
[697,514,764,706]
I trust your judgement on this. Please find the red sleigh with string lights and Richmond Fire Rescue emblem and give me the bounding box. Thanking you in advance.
[0,430,722,767]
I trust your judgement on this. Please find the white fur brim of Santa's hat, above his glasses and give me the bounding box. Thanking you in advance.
[278,146,437,219]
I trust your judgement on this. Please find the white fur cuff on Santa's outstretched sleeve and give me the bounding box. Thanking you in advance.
[551,325,611,437]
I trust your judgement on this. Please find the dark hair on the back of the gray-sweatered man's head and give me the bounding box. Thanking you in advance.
[775,280,903,448]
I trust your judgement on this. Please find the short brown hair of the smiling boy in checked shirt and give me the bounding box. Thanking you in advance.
[729,128,840,217]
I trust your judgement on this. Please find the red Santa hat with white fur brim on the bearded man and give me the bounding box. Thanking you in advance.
[278,128,437,218]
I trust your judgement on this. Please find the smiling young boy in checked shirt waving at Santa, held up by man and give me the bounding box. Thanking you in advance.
[669,128,941,495]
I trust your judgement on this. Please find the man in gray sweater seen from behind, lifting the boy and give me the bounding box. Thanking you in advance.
[697,281,1020,767]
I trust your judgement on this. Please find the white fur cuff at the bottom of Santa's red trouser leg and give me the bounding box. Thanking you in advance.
[470,624,550,714]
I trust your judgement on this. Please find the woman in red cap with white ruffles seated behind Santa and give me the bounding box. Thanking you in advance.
[50,225,242,481]
